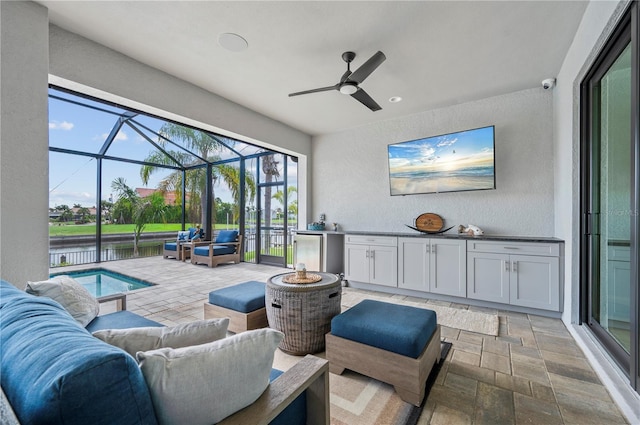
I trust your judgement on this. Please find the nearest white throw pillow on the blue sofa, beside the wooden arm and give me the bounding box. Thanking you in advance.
[138,328,284,425]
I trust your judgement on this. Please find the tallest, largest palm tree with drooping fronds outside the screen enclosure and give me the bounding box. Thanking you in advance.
[140,123,255,226]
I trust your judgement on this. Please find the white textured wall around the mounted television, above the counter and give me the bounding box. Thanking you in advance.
[310,88,554,236]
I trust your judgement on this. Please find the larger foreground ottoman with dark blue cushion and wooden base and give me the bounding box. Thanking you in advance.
[326,300,440,406]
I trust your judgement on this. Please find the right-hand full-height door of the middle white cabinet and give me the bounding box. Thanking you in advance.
[429,239,467,297]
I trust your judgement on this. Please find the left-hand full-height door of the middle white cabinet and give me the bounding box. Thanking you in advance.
[398,238,429,292]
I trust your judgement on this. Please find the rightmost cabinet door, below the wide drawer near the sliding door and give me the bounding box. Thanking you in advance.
[509,255,560,311]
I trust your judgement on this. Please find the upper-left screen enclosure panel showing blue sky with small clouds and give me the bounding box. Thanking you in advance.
[49,93,122,154]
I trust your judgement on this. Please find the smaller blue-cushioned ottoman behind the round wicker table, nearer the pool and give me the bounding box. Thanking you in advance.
[204,281,269,333]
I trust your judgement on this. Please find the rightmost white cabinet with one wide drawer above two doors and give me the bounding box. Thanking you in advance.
[467,241,561,311]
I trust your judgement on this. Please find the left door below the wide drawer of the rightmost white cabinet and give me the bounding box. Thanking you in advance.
[467,252,510,304]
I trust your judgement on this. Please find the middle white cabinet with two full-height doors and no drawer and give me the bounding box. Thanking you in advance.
[398,237,467,297]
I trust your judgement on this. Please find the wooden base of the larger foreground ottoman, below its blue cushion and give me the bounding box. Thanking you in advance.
[325,325,440,406]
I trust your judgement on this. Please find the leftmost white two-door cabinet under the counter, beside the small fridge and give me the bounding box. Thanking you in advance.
[344,235,398,287]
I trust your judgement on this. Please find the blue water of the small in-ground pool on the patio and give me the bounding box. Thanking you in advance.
[50,269,153,297]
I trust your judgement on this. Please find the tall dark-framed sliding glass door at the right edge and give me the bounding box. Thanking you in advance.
[581,0,640,389]
